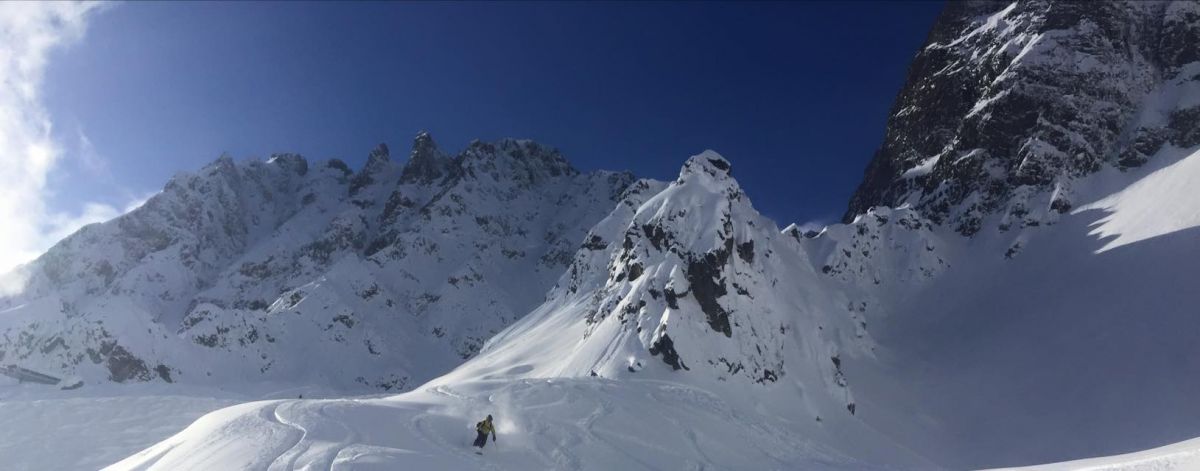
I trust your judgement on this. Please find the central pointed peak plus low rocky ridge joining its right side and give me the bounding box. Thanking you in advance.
[434,151,948,424]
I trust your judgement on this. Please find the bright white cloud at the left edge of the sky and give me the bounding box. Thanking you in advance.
[0,1,119,279]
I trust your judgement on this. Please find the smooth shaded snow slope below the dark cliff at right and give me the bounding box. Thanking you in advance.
[847,149,1200,467]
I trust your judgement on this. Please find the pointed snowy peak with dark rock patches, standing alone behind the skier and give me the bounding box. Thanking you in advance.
[458,151,868,415]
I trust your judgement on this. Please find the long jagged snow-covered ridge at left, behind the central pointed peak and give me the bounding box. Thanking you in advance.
[0,133,632,389]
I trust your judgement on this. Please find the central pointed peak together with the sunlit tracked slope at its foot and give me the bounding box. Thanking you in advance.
[113,151,932,470]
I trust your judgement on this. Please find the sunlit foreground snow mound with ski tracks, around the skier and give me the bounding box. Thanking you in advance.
[108,378,926,470]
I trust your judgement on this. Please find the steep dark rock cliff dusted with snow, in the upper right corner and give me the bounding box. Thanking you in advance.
[845,0,1200,236]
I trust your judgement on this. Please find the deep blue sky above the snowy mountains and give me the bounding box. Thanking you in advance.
[44,1,941,226]
